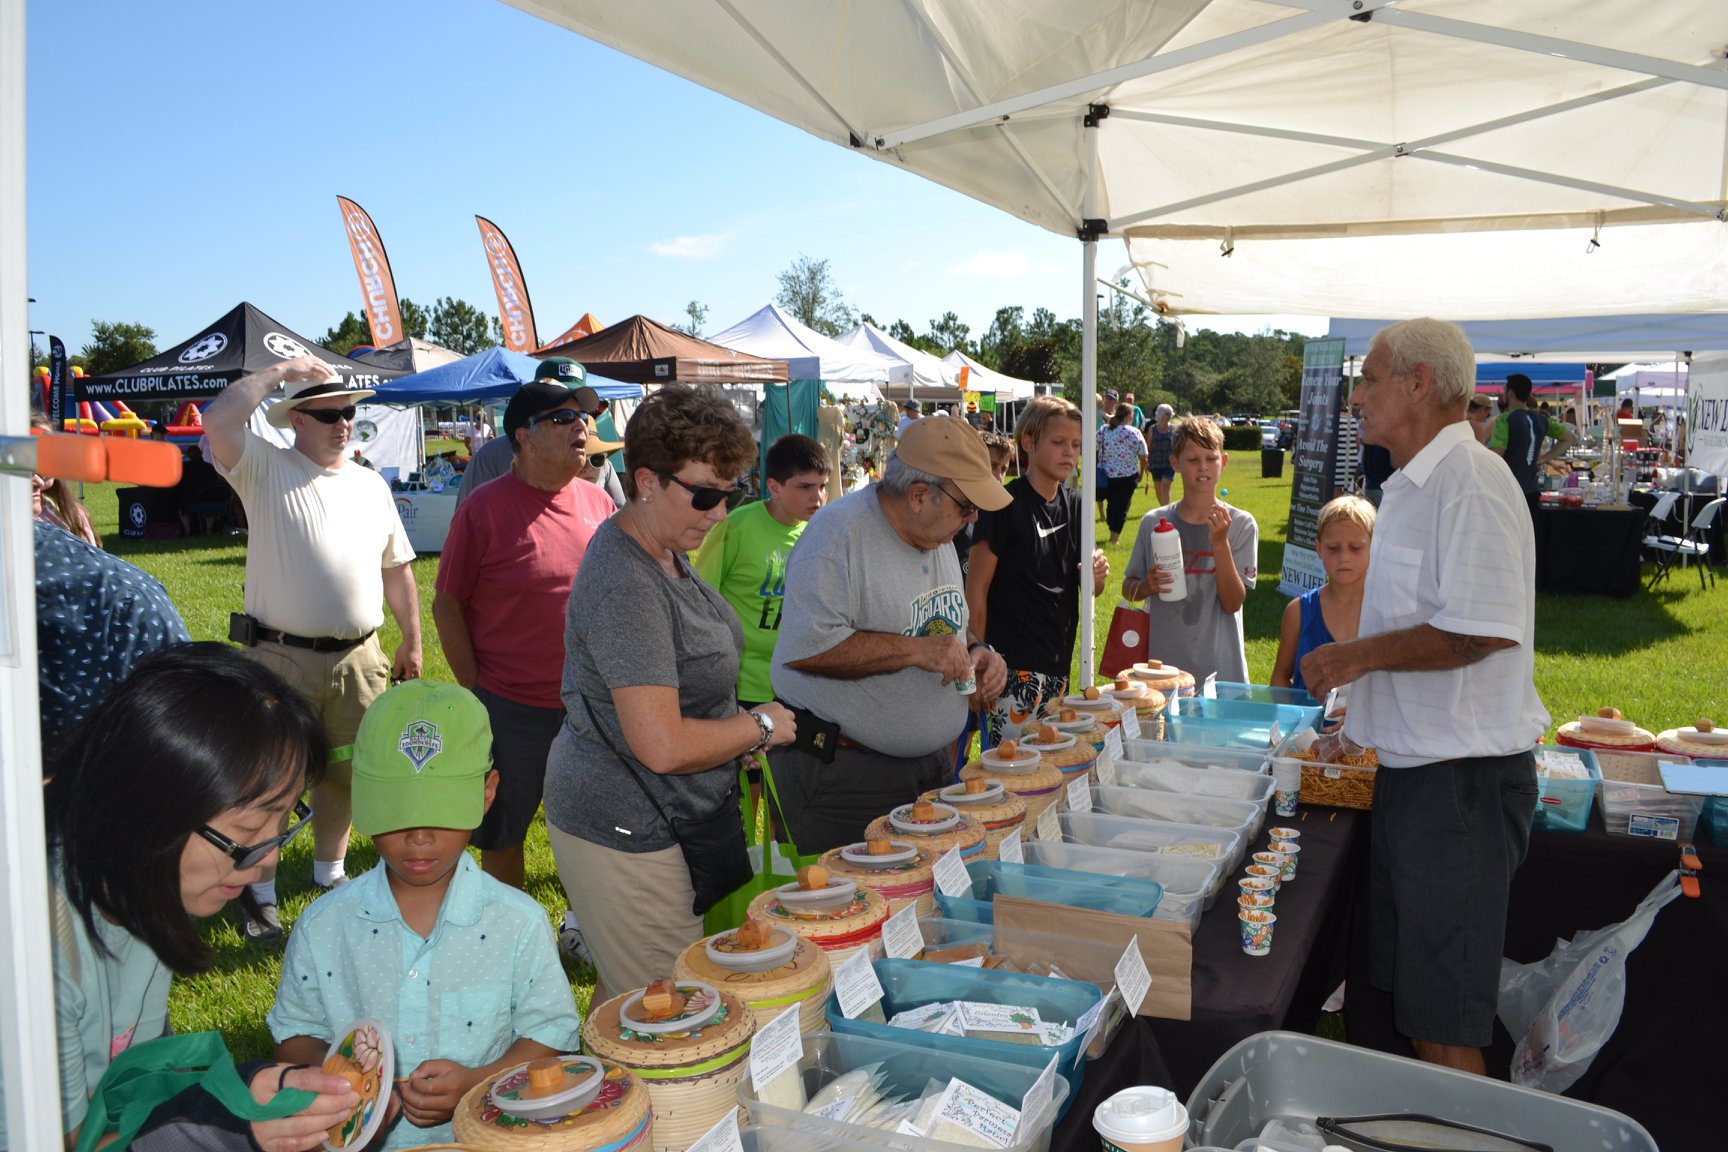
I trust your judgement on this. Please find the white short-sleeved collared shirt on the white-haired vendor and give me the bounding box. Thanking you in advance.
[1344,420,1548,767]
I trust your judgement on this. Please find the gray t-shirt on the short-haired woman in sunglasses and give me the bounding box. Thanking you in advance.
[546,520,745,851]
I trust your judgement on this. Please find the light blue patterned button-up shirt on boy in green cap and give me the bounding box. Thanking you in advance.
[266,853,582,1149]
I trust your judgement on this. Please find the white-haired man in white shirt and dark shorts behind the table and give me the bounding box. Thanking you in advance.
[1301,320,1548,1073]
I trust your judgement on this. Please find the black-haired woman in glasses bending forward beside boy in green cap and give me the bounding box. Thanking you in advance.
[19,644,359,1150]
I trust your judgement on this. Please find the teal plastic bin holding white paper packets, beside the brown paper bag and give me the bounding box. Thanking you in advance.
[828,960,1104,1121]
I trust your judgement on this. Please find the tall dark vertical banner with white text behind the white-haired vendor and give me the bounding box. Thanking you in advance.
[1279,340,1344,596]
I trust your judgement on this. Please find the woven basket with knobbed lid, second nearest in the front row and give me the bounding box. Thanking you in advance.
[582,979,755,1152]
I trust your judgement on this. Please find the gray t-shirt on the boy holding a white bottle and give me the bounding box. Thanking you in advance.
[1101,504,1260,684]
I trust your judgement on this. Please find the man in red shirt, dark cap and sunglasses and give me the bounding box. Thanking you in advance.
[432,378,620,888]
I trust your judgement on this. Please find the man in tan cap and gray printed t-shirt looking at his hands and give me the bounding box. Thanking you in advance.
[769,420,1011,853]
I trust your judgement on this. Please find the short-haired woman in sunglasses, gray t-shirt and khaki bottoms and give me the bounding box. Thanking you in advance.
[546,385,793,1003]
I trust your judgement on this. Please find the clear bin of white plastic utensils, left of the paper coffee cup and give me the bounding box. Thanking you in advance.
[738,1033,1068,1152]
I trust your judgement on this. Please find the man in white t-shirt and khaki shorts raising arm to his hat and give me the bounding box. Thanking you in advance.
[204,356,420,941]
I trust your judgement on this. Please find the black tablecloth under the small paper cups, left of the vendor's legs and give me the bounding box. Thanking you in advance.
[1051,807,1369,1152]
